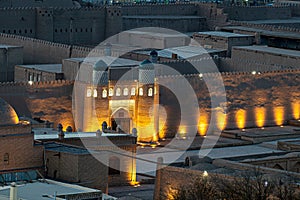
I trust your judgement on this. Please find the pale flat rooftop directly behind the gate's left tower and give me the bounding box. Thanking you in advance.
[65,56,140,67]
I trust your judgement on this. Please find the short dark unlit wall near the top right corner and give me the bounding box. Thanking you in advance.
[224,6,292,21]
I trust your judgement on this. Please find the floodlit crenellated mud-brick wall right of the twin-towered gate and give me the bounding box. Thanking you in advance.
[159,70,300,137]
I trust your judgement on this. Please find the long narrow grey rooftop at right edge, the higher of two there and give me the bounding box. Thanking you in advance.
[222,26,300,40]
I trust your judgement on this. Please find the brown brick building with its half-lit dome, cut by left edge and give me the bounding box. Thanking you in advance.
[0,98,43,177]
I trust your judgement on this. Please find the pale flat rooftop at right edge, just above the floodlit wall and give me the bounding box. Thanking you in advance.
[233,45,300,57]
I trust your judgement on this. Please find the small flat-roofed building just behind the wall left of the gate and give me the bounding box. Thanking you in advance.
[15,64,64,82]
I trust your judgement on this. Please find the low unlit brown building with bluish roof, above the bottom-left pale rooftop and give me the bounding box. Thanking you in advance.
[45,143,108,192]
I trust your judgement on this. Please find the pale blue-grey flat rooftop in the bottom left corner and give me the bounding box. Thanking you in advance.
[0,179,102,200]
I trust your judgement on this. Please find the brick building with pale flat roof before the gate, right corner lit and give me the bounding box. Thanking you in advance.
[33,128,137,191]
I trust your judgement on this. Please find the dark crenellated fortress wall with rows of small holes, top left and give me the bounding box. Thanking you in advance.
[0,6,106,45]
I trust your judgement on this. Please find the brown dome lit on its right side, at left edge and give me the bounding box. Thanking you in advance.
[0,98,19,125]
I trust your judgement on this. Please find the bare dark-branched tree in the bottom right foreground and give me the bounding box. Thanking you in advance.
[173,168,300,200]
